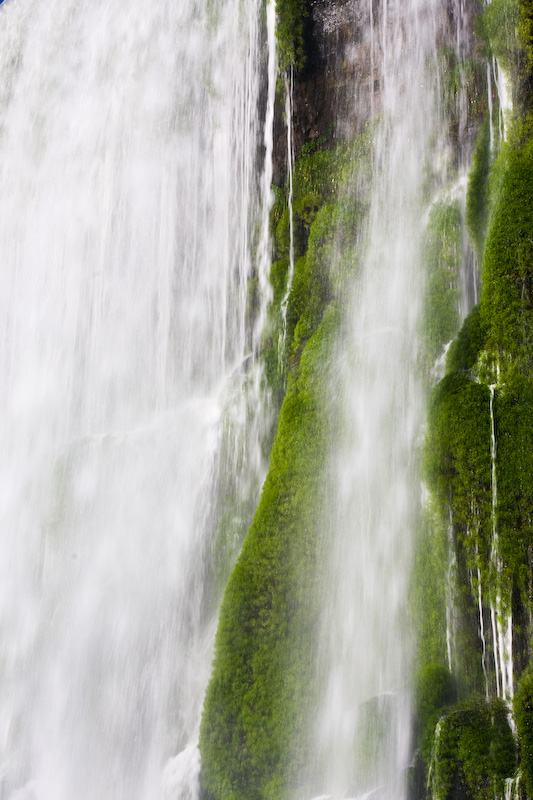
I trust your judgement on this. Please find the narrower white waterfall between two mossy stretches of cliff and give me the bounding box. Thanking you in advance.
[310,0,447,800]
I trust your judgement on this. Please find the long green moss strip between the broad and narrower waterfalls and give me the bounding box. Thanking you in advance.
[200,128,370,800]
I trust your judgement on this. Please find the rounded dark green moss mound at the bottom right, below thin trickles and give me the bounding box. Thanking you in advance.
[431,700,516,800]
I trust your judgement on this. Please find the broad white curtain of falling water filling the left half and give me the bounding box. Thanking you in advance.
[0,0,266,800]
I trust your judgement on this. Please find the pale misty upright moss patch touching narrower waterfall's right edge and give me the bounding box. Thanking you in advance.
[422,201,463,367]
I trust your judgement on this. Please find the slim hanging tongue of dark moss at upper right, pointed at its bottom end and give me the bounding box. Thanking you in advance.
[465,117,491,259]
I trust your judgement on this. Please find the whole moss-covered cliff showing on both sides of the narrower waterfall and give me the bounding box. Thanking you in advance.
[200,0,533,800]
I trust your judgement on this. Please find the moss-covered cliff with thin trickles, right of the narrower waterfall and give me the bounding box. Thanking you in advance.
[413,0,533,800]
